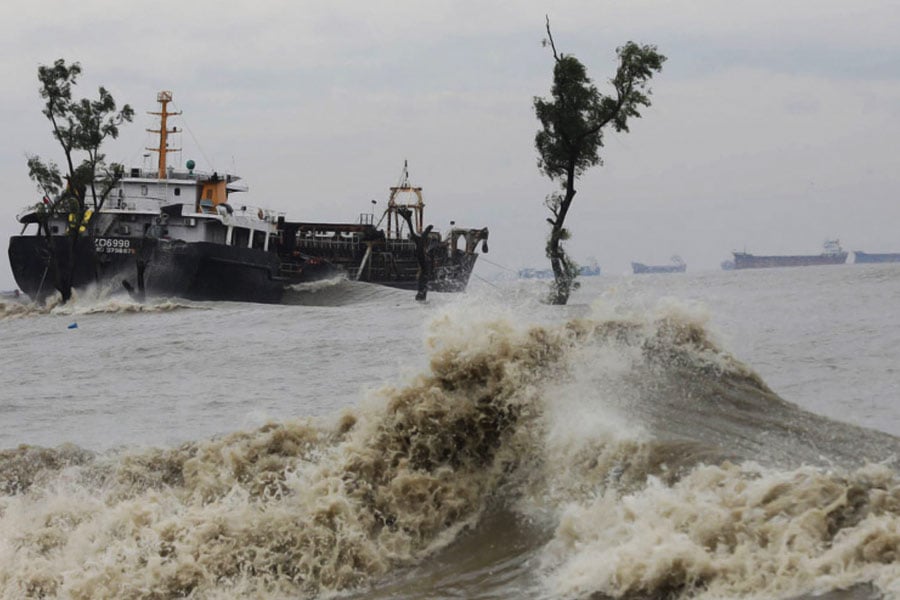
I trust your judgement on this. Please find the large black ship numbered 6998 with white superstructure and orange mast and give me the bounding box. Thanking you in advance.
[8,91,488,303]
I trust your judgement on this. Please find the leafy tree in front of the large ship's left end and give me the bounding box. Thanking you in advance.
[28,58,134,302]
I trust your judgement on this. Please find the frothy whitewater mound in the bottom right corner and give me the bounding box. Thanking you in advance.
[544,463,900,598]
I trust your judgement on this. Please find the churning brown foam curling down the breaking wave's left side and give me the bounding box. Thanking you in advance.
[0,314,569,597]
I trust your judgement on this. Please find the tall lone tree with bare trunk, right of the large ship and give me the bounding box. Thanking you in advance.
[534,18,666,304]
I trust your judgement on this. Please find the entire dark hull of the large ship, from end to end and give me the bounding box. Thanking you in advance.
[9,230,478,304]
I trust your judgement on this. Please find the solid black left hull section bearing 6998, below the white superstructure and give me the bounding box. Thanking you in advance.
[9,236,334,303]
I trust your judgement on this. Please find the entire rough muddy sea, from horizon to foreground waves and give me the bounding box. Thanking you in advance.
[0,265,900,600]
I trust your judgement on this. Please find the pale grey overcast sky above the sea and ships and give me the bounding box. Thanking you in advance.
[0,0,900,289]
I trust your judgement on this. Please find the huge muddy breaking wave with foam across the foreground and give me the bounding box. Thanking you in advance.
[0,311,900,598]
